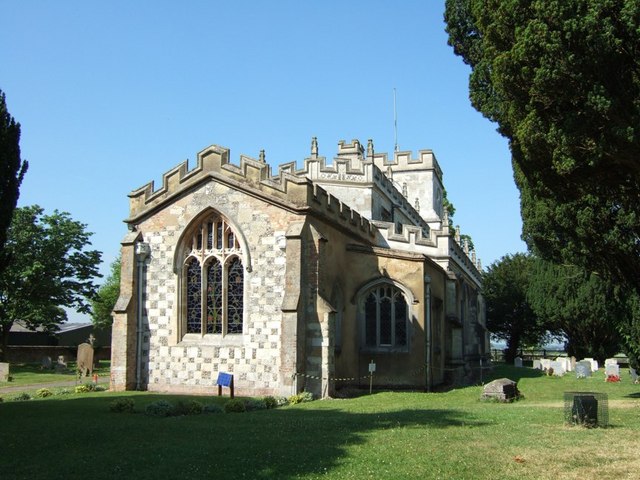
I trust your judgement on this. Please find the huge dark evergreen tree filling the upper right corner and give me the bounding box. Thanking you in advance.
[445,0,640,292]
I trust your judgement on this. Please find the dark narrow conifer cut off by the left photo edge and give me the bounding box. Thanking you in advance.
[0,90,29,273]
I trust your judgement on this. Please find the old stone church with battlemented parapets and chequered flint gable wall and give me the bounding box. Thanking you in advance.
[111,138,489,396]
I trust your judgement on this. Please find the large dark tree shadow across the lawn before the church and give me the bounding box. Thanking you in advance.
[0,394,486,479]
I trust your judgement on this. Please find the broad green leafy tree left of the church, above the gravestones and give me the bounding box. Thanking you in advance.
[0,205,101,358]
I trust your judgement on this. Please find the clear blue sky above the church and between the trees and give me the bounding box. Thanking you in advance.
[0,0,526,320]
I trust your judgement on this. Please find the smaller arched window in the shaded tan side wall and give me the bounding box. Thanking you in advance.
[362,283,409,350]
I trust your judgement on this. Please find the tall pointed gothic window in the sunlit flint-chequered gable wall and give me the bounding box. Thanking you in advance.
[183,215,244,335]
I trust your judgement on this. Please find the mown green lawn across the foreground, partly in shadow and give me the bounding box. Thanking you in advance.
[0,367,640,480]
